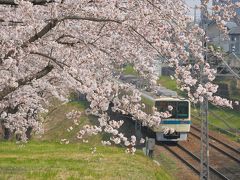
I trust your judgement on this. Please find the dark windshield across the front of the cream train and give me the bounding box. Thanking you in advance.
[155,101,189,119]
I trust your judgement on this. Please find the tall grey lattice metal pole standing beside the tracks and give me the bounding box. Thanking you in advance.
[200,0,209,180]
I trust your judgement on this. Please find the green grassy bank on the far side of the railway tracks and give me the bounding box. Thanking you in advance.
[158,76,240,140]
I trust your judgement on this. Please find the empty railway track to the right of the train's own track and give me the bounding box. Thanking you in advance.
[189,125,240,163]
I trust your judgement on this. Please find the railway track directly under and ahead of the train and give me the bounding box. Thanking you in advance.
[161,144,229,180]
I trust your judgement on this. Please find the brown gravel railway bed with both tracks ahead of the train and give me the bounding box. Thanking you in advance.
[157,125,240,179]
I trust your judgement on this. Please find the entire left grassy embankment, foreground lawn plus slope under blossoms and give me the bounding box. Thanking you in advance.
[0,102,172,180]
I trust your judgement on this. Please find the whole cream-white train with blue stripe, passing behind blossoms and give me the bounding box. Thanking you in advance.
[119,76,191,141]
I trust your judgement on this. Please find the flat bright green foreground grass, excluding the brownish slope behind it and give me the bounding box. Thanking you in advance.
[0,142,171,180]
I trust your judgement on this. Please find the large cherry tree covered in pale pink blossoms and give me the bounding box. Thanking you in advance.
[0,0,239,146]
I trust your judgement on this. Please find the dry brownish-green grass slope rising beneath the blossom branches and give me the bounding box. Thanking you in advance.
[38,101,101,145]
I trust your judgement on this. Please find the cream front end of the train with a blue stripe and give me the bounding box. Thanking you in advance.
[153,97,191,141]
